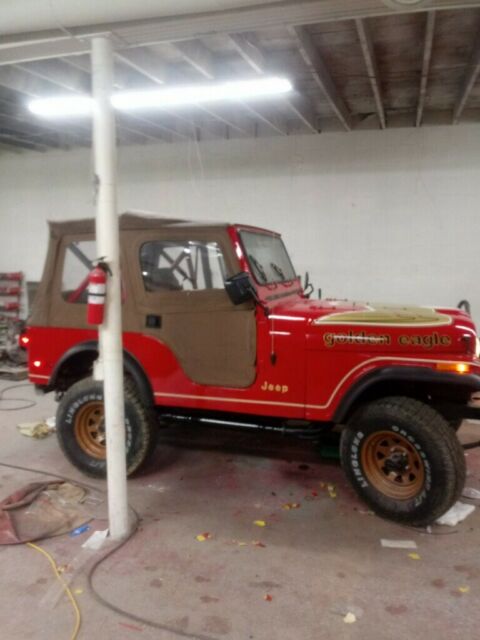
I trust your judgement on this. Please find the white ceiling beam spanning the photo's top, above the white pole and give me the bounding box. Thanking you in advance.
[0,0,480,64]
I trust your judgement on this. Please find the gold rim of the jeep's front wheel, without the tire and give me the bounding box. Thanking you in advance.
[361,431,425,500]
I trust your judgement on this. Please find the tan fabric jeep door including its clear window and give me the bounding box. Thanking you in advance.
[122,225,256,388]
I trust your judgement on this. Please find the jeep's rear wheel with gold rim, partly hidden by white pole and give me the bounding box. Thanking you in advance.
[56,378,157,478]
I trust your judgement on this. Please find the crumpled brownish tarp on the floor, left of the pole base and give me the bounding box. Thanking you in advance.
[0,480,91,544]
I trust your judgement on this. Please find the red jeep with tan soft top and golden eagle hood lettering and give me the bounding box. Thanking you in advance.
[24,214,480,525]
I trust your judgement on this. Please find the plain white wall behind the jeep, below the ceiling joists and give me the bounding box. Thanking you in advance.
[0,125,480,318]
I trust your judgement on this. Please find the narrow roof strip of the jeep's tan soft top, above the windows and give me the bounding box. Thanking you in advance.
[48,211,229,238]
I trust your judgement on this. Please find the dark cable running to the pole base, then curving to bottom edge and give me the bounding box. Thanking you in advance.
[0,462,217,640]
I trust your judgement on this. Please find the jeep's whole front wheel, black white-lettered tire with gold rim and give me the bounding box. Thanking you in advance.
[340,397,466,526]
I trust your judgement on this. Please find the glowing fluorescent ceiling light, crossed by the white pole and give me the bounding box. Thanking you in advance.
[28,77,293,118]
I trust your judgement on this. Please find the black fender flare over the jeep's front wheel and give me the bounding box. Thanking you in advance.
[333,366,480,424]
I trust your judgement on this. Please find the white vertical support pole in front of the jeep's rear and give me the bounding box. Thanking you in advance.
[92,36,130,540]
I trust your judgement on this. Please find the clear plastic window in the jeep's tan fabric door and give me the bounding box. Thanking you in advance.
[140,240,227,292]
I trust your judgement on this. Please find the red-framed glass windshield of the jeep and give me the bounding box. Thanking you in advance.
[240,231,297,284]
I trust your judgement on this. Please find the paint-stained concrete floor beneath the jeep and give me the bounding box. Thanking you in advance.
[0,382,480,640]
